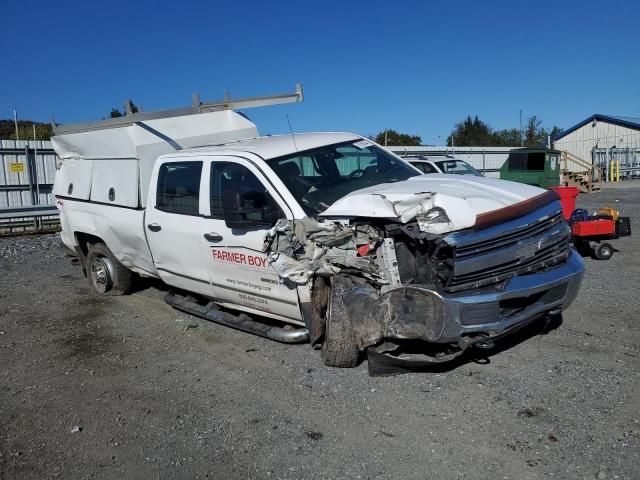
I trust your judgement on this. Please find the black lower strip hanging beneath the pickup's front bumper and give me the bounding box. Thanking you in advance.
[368,314,562,376]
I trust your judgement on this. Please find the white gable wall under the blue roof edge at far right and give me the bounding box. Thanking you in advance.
[553,120,640,163]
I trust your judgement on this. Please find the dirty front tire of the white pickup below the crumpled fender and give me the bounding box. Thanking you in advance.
[321,276,360,368]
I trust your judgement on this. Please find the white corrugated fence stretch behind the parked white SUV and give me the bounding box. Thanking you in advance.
[387,146,520,178]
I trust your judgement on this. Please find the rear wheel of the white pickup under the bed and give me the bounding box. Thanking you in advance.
[86,243,133,295]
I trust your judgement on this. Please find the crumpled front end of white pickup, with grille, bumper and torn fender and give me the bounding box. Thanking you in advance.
[264,189,583,366]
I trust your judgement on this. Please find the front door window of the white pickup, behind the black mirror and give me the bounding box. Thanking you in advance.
[210,162,284,220]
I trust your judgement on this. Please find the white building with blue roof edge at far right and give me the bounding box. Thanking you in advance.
[553,114,640,163]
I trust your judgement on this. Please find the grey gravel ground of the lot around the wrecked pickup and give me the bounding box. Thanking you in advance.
[0,186,640,479]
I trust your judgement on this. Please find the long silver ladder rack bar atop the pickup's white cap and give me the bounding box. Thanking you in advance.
[52,83,304,135]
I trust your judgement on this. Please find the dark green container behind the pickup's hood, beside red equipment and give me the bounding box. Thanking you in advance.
[500,148,560,188]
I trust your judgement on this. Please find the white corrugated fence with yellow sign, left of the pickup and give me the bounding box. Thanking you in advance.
[0,140,57,208]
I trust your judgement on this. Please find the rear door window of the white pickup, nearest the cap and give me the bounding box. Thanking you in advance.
[156,162,202,215]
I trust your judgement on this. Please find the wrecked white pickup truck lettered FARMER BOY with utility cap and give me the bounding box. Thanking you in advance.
[52,87,583,367]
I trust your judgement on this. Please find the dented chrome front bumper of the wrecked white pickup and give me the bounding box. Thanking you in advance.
[384,249,584,343]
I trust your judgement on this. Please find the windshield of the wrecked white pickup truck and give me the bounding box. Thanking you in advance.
[268,140,420,215]
